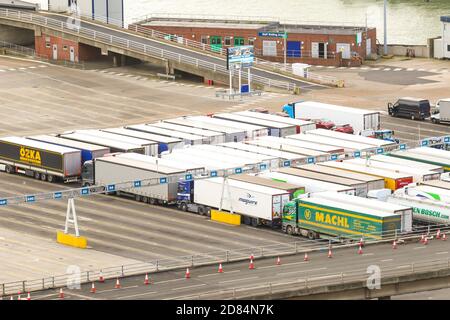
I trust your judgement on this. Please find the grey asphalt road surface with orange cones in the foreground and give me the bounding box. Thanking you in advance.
[27,239,450,300]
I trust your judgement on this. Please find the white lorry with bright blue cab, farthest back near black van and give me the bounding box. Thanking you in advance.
[283,101,380,134]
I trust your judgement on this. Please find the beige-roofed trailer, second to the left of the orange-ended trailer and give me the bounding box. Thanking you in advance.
[278,167,369,197]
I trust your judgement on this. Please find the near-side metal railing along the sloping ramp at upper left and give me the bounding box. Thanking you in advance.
[0,9,297,91]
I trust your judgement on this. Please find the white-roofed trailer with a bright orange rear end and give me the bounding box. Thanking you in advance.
[319,161,413,191]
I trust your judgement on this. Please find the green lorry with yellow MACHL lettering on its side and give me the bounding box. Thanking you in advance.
[282,196,401,240]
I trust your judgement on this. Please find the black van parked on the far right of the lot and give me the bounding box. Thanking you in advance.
[388,98,431,120]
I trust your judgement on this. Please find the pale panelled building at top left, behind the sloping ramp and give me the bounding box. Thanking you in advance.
[48,0,124,27]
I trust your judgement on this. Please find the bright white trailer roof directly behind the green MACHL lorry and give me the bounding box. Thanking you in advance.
[259,171,356,195]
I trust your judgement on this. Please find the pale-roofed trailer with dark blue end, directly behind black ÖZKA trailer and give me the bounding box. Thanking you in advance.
[27,135,111,164]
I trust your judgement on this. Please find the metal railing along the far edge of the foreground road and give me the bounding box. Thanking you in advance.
[0,225,450,296]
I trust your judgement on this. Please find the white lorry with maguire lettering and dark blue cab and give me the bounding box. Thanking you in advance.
[178,177,290,227]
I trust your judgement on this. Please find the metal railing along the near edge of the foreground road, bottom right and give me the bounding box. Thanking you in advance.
[176,258,450,300]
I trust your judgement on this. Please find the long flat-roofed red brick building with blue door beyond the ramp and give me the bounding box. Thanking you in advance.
[139,18,376,66]
